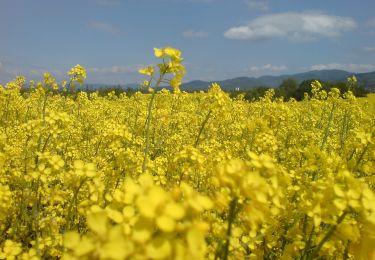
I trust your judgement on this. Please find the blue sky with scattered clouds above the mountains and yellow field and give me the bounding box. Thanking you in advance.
[0,0,375,84]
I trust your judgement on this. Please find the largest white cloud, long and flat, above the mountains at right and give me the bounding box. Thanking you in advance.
[224,12,357,41]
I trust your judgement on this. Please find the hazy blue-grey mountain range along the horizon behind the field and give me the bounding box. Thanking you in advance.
[86,70,375,92]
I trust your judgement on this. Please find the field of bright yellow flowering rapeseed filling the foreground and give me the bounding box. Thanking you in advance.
[0,47,375,260]
